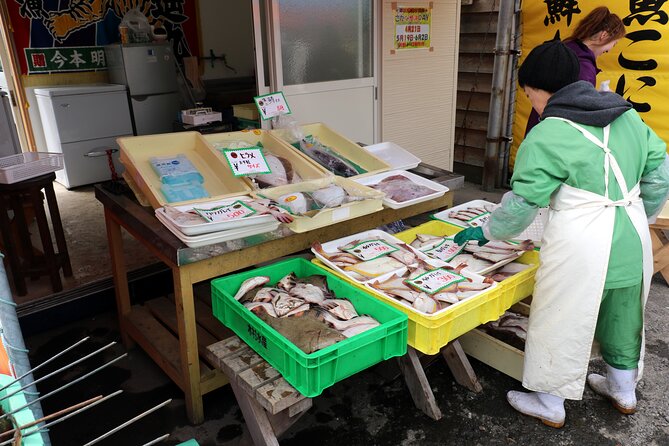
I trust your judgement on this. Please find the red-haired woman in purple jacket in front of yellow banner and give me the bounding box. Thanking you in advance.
[525,6,625,135]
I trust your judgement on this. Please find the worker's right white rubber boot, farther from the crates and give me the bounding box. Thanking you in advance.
[588,364,637,415]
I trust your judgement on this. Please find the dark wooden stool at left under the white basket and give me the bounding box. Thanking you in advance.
[0,172,72,296]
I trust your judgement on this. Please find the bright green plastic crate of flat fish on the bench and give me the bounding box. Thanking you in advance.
[211,258,408,397]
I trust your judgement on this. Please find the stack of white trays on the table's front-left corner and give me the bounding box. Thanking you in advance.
[155,196,280,248]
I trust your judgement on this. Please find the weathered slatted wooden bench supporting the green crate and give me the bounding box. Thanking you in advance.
[207,336,312,446]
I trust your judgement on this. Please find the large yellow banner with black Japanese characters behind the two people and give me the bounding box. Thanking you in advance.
[509,0,669,168]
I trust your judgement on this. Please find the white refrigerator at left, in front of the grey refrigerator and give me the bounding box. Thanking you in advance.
[35,84,132,189]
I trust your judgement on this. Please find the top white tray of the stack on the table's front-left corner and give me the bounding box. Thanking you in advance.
[155,195,275,236]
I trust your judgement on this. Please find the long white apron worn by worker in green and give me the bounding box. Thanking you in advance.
[523,118,653,400]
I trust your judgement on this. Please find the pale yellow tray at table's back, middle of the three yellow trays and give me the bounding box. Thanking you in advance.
[203,129,330,191]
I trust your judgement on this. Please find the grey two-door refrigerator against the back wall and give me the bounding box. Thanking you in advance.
[105,42,181,135]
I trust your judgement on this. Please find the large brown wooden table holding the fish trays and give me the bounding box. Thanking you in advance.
[95,186,453,424]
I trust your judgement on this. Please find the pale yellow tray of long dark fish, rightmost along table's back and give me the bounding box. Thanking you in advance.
[271,123,390,178]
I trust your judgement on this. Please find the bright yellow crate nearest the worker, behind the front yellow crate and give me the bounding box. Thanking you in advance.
[395,220,539,310]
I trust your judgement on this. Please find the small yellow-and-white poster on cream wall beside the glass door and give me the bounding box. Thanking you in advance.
[393,5,432,50]
